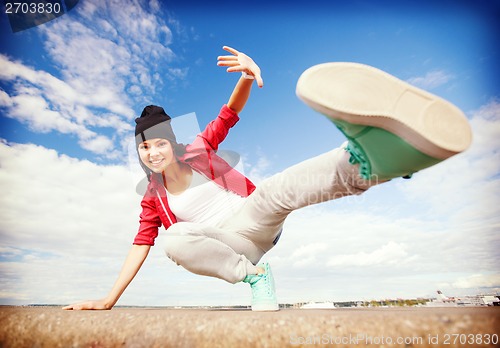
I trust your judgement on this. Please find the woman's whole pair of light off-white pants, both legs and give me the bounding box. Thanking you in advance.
[165,147,376,283]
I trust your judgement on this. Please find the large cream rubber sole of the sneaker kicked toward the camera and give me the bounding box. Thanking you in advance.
[296,63,472,160]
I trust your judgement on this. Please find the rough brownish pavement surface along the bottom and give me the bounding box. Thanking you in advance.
[0,306,500,348]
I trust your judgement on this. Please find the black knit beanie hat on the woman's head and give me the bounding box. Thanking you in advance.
[135,105,177,145]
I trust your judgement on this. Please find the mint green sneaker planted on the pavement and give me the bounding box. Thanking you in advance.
[243,263,279,311]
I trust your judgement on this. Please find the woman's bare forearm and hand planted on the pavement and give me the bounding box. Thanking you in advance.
[63,245,151,310]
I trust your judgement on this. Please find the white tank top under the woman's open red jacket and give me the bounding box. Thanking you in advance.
[166,170,245,226]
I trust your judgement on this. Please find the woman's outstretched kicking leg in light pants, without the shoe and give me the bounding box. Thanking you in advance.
[219,146,377,252]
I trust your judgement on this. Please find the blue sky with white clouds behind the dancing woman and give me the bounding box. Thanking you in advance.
[0,0,500,305]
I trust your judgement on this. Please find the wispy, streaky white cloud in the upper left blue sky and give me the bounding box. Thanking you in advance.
[0,0,187,159]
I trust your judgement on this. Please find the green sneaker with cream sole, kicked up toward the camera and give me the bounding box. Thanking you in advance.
[297,63,472,180]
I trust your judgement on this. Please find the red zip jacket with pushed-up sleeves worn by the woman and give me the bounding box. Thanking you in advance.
[134,105,255,245]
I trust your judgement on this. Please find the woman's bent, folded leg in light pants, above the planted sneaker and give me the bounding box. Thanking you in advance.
[165,222,264,283]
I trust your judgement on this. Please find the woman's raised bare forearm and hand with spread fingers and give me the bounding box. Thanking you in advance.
[217,46,264,113]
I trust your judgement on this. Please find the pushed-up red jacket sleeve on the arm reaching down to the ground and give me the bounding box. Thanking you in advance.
[134,197,161,246]
